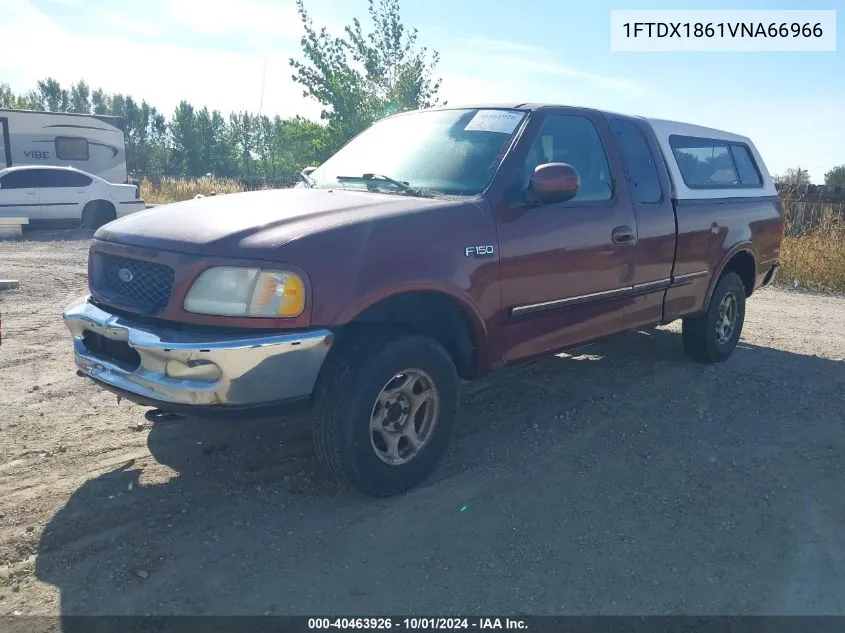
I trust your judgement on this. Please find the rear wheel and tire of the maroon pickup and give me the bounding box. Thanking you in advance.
[682,272,745,363]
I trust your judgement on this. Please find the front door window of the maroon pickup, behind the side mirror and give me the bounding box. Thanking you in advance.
[522,115,613,202]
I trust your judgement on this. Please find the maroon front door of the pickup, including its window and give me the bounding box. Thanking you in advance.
[496,109,637,362]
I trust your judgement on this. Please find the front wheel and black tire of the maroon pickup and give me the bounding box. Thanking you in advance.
[314,330,458,497]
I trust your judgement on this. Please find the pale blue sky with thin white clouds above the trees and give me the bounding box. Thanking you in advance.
[0,0,845,182]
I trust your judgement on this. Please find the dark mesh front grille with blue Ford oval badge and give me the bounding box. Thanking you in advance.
[91,253,174,312]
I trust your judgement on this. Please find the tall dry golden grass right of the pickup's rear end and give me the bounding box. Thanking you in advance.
[779,228,845,292]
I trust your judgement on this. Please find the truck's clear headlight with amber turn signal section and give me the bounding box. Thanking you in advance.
[185,266,305,318]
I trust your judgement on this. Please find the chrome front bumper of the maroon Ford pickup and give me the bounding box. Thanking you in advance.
[63,297,334,408]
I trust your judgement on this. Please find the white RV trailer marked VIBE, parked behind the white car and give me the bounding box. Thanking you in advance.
[0,109,128,184]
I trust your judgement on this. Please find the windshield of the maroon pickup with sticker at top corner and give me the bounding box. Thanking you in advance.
[309,109,525,196]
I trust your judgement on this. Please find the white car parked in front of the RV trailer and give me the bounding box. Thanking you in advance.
[0,165,146,228]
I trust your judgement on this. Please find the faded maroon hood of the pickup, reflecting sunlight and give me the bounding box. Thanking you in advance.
[94,188,454,257]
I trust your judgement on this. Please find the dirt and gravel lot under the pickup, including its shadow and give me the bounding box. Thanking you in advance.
[0,232,845,615]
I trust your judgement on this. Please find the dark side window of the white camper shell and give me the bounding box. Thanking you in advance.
[669,134,763,189]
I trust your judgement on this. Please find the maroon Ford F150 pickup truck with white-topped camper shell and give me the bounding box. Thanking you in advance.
[64,104,783,496]
